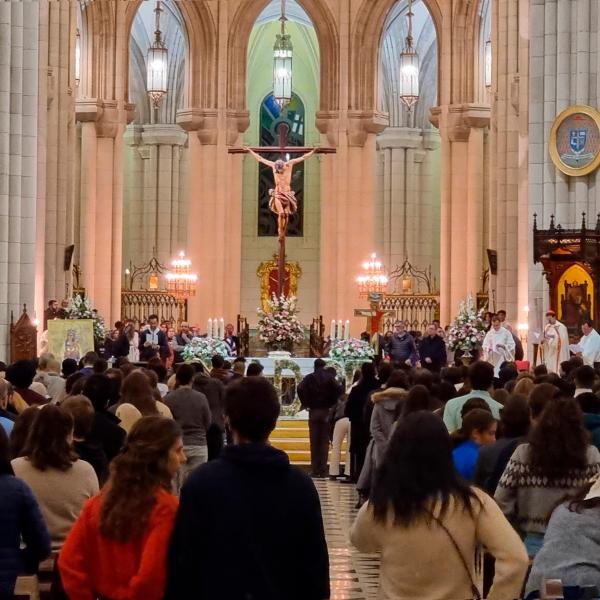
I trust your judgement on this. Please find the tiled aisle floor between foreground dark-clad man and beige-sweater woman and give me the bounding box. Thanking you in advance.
[315,480,379,600]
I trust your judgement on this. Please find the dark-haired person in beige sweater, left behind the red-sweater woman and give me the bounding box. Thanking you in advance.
[11,405,99,549]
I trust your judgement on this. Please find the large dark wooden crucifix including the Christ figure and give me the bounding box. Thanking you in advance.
[229,123,335,296]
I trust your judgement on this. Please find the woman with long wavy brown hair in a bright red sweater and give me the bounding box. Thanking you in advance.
[58,416,185,600]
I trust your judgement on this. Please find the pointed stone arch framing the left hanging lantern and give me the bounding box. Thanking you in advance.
[125,0,217,108]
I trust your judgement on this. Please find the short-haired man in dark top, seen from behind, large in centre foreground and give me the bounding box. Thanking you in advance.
[165,377,330,600]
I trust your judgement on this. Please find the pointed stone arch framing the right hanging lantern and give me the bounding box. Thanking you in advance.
[349,0,444,112]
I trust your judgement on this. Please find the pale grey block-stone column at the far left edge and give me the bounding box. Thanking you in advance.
[0,2,41,361]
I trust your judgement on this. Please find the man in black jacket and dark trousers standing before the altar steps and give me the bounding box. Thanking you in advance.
[298,358,344,479]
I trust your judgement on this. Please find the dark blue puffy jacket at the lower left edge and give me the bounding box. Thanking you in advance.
[0,475,50,600]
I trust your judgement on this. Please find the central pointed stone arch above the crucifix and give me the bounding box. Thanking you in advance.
[227,0,339,111]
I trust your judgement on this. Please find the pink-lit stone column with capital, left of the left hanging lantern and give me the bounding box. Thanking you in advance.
[77,99,133,330]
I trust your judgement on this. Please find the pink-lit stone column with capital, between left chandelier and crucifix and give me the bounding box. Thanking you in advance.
[177,109,248,327]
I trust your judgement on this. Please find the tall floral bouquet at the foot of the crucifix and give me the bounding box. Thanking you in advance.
[257,294,304,349]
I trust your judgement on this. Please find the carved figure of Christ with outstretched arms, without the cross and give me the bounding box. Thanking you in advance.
[244,148,317,242]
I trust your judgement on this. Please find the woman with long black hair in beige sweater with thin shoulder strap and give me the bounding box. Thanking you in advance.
[351,411,527,600]
